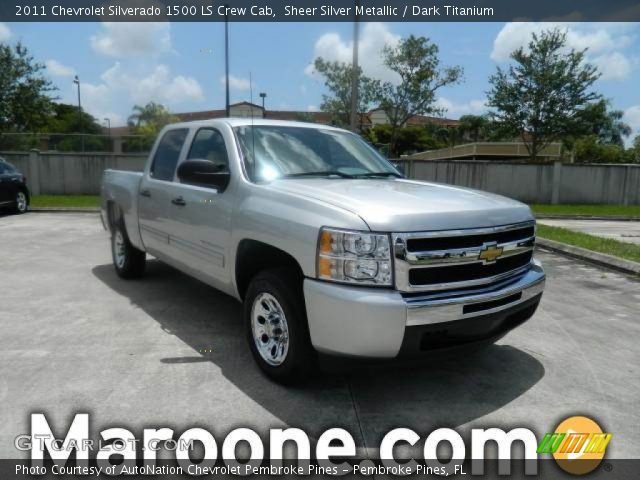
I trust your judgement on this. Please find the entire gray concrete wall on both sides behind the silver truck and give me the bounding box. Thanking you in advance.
[0,151,640,205]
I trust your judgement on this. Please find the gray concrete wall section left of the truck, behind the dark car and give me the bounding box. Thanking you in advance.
[0,151,147,195]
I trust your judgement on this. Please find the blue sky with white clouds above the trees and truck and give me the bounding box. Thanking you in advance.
[0,22,640,141]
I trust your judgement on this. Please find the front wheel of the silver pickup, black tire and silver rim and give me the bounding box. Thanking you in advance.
[244,269,315,383]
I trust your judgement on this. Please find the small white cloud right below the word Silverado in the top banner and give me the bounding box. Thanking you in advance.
[91,22,171,58]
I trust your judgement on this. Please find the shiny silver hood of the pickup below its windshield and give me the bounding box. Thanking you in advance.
[269,178,533,232]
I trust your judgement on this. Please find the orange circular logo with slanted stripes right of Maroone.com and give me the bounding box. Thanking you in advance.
[553,417,611,475]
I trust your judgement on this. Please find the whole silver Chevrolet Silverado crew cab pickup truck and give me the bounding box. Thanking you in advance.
[101,118,545,381]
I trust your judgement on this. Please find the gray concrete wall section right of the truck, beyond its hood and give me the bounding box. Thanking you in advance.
[397,159,640,205]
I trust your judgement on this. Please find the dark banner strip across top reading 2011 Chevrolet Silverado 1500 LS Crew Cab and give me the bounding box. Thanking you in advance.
[0,0,640,22]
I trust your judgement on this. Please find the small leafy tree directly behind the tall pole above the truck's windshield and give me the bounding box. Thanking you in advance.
[313,57,380,127]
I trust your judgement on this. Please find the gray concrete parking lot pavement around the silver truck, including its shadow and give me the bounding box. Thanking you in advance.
[0,213,640,458]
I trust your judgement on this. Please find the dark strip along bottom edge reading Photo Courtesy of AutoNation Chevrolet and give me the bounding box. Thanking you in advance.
[0,458,640,480]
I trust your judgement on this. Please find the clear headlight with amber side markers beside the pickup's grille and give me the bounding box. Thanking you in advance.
[317,228,392,286]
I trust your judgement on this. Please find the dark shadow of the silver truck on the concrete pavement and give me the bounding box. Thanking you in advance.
[93,260,544,446]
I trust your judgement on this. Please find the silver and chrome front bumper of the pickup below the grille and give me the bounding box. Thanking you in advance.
[304,262,545,358]
